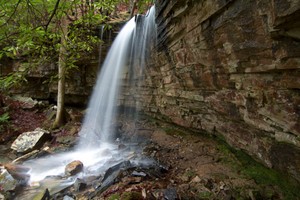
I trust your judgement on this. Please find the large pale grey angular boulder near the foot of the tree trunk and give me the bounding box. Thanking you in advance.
[11,128,50,153]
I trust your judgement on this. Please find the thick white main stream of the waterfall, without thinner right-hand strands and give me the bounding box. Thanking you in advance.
[78,16,136,145]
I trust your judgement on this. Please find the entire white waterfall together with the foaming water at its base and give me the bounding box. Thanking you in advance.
[24,7,156,183]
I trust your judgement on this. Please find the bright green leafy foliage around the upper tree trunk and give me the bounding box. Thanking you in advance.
[0,0,120,90]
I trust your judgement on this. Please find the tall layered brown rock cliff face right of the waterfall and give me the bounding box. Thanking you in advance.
[125,0,300,181]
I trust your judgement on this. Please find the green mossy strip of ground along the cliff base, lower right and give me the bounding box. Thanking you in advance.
[218,138,300,199]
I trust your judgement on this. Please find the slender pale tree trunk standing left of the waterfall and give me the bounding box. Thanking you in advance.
[53,18,68,128]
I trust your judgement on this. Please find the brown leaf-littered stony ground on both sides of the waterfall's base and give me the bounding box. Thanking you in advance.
[0,97,300,200]
